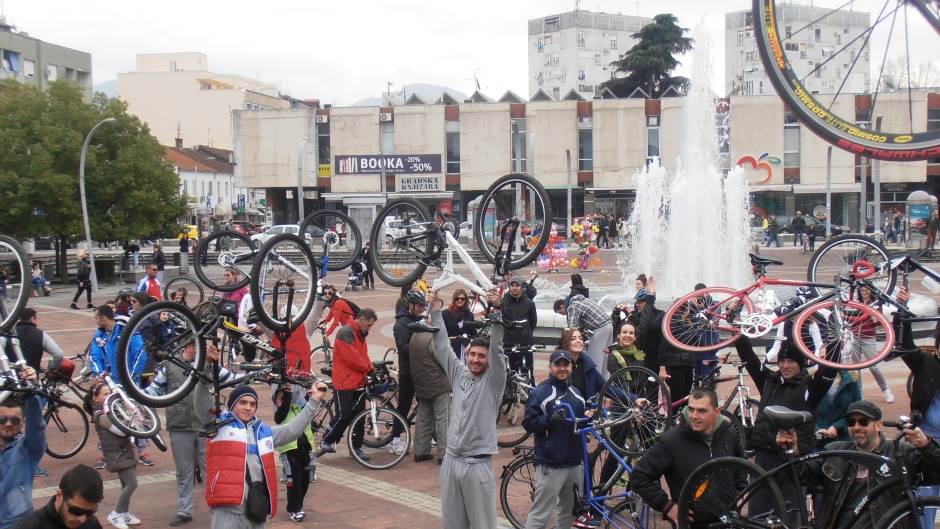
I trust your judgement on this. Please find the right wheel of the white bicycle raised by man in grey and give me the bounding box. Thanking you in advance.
[473,173,552,270]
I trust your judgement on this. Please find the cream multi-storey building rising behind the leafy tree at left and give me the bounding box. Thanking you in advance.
[118,52,291,150]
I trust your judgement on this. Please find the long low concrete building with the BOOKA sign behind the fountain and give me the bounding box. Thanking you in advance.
[235,92,940,233]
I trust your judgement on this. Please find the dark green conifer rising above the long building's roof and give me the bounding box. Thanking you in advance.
[601,13,693,98]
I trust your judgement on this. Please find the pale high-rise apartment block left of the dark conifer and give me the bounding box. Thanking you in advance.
[529,10,652,101]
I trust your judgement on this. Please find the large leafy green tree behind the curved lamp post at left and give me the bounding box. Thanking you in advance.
[0,80,185,277]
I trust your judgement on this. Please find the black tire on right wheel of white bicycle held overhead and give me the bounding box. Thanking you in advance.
[473,173,552,270]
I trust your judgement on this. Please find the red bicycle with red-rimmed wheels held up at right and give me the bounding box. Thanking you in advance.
[663,260,894,369]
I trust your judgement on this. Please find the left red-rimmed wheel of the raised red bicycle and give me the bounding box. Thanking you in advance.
[663,287,754,352]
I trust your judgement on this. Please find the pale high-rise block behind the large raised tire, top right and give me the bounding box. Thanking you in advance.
[725,2,871,95]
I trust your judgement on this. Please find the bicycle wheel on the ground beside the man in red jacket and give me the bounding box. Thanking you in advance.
[346,408,411,470]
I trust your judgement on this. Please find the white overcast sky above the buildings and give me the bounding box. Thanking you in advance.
[0,0,936,105]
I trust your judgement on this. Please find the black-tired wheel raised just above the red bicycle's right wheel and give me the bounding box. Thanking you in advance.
[806,235,898,296]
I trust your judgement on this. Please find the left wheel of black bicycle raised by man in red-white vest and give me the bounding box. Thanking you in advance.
[117,301,206,408]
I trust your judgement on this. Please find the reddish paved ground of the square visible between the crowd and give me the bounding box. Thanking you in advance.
[23,247,926,529]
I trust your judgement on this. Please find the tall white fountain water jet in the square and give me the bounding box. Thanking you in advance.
[624,29,753,300]
